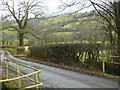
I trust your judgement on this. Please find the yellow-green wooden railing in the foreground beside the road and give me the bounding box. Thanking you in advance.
[0,59,43,89]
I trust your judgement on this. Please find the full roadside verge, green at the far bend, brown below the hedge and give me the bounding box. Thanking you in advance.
[0,47,120,79]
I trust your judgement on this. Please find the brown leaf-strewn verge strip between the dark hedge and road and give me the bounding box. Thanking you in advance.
[22,57,120,80]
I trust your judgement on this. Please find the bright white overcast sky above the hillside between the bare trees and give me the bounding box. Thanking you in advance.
[0,0,120,16]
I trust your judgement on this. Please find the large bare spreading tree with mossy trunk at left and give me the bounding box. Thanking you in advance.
[1,0,44,46]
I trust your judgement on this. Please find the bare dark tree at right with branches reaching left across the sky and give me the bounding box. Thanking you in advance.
[59,0,120,55]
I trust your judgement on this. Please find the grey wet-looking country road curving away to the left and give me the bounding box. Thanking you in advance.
[0,51,118,88]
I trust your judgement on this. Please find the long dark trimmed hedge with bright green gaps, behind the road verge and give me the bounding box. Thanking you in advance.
[28,44,120,74]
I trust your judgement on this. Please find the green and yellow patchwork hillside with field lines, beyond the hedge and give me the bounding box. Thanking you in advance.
[0,12,106,44]
